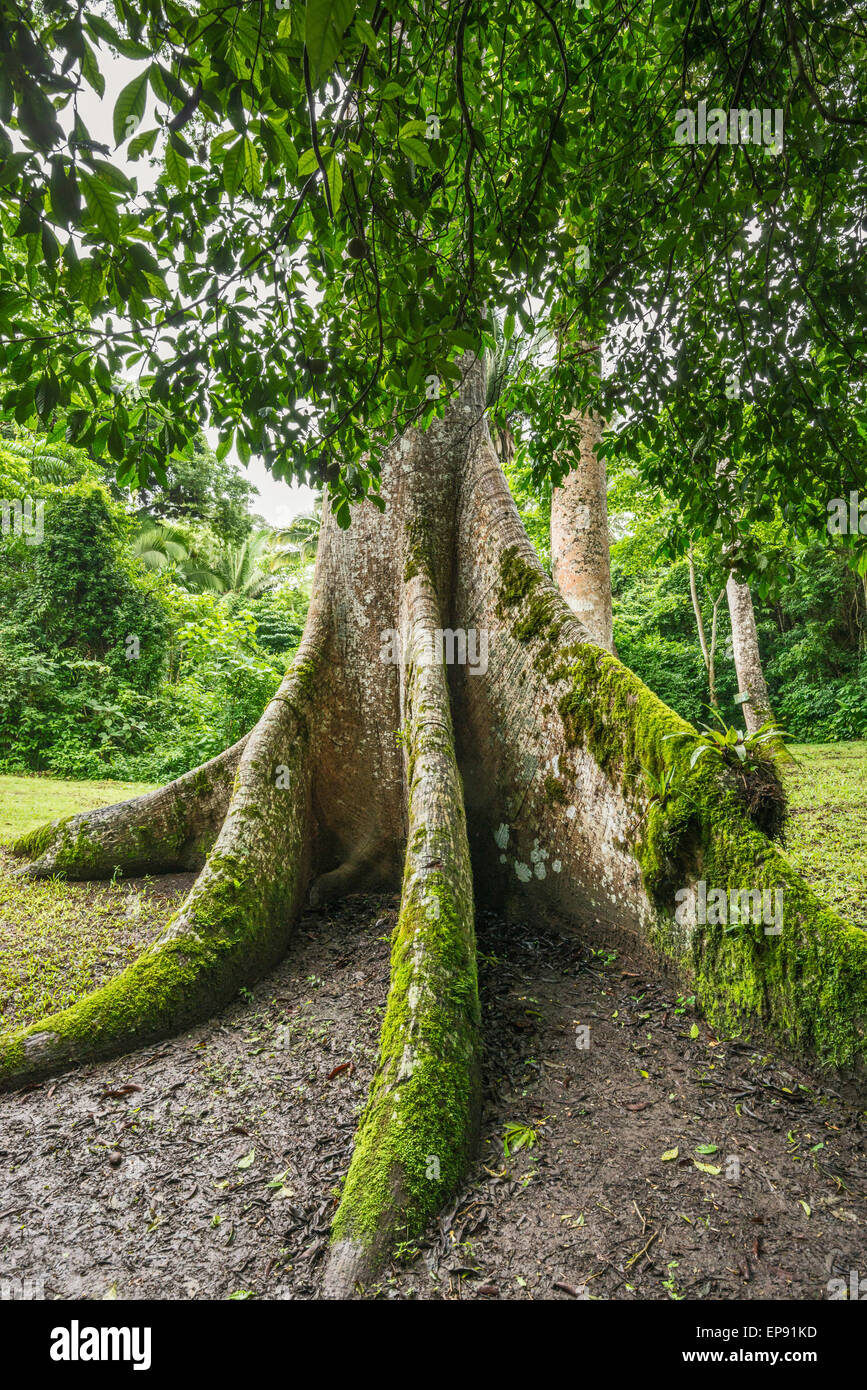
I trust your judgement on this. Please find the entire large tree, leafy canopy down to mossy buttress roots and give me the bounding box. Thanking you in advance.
[0,0,867,1295]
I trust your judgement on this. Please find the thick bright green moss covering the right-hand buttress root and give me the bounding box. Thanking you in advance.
[499,536,867,1076]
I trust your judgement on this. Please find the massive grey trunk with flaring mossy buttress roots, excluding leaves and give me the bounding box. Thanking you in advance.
[0,366,867,1297]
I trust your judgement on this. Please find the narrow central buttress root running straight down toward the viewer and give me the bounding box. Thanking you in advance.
[324,553,479,1298]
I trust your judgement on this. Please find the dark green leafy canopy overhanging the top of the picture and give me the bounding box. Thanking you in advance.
[0,0,867,525]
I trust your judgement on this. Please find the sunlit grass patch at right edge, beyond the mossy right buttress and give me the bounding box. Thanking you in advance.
[786,742,867,927]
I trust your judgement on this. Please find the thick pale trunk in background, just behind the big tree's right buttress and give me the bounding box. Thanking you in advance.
[550,416,614,652]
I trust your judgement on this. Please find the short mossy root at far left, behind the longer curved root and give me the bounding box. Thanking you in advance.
[11,735,249,878]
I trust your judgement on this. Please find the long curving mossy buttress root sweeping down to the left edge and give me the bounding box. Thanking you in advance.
[0,644,322,1090]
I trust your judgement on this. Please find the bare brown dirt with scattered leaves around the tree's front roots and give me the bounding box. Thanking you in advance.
[0,876,867,1300]
